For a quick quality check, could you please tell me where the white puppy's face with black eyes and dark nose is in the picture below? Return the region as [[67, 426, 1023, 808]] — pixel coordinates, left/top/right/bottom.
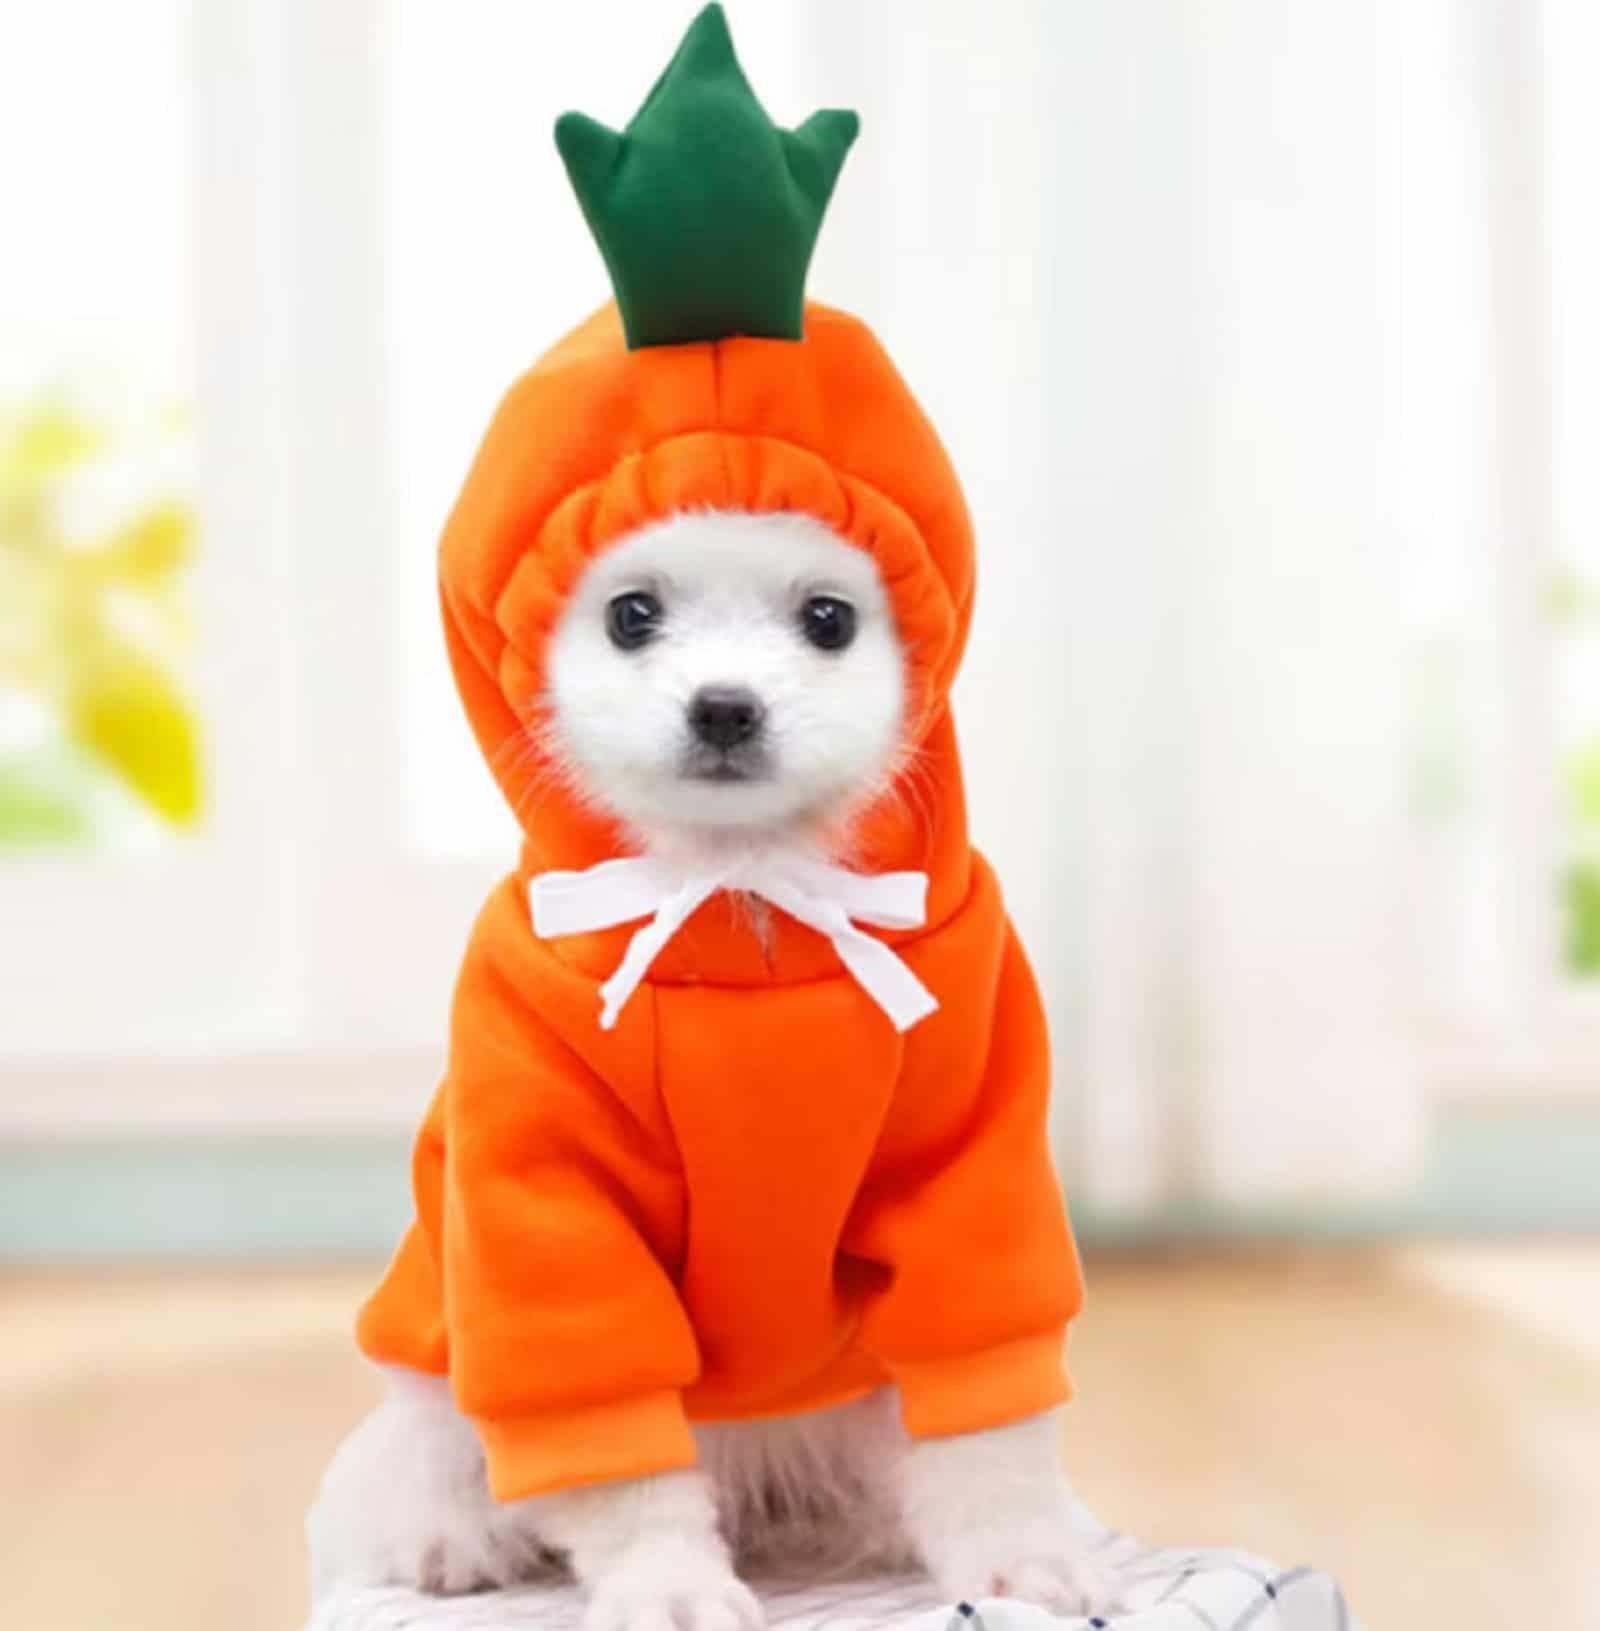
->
[[546, 511, 905, 842]]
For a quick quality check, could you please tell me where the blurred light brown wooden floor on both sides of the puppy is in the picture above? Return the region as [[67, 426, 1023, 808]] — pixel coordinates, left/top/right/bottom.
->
[[0, 1248, 1600, 1631]]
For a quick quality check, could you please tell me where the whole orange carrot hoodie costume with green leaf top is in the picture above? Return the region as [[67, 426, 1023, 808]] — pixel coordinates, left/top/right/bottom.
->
[[359, 7, 1081, 1501]]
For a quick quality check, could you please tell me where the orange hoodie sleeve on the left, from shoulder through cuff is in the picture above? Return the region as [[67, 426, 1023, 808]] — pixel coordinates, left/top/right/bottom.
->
[[442, 902, 700, 1501]]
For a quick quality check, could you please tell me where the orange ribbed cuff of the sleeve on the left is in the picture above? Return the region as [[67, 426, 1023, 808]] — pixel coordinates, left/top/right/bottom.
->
[[478, 1390, 695, 1501]]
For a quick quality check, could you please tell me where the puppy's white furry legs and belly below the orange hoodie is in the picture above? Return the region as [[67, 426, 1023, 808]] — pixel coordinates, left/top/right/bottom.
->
[[307, 1372, 1114, 1631]]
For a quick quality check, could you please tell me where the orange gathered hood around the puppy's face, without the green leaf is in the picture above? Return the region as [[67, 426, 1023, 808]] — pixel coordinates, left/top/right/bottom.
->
[[440, 305, 972, 893]]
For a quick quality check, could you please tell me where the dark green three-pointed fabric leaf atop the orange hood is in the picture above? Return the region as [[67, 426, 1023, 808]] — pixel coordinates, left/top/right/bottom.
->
[[556, 5, 860, 349]]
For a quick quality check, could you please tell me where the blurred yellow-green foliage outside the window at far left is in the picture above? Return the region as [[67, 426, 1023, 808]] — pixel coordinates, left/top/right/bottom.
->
[[0, 401, 201, 846]]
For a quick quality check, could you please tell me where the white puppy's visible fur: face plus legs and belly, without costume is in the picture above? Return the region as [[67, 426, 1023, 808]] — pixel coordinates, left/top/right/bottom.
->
[[308, 512, 1109, 1631]]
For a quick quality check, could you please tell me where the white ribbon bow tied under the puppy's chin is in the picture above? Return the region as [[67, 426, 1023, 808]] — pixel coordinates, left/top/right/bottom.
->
[[528, 855, 939, 1031]]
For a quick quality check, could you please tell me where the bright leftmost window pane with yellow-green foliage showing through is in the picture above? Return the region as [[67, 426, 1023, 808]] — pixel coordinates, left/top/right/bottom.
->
[[0, 0, 202, 855]]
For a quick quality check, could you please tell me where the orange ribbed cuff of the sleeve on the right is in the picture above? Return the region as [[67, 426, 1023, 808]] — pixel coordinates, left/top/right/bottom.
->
[[889, 1329, 1072, 1439]]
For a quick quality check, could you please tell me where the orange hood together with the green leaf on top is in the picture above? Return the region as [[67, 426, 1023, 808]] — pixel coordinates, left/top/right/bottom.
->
[[440, 7, 972, 978]]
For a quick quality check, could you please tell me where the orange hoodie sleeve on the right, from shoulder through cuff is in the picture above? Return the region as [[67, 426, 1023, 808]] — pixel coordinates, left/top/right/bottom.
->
[[848, 900, 1083, 1437]]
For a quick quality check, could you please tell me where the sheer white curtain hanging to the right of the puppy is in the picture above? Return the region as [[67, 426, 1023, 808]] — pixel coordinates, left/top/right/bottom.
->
[[801, 0, 1454, 1215]]
